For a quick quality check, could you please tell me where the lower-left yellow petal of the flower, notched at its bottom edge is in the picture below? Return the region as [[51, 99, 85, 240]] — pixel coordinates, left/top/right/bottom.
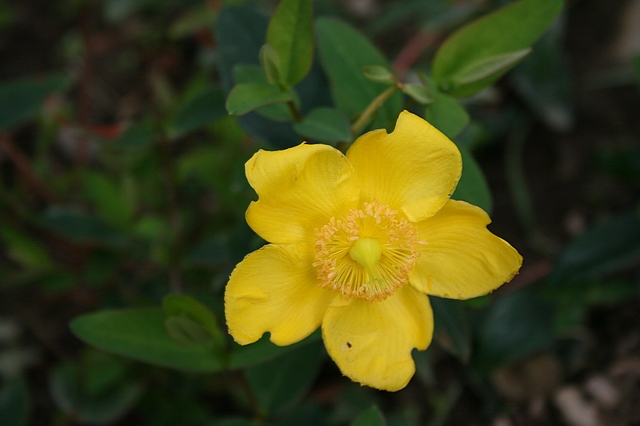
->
[[224, 245, 336, 346]]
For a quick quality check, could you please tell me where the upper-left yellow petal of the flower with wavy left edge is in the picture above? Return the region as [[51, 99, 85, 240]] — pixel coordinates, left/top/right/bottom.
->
[[245, 144, 359, 244]]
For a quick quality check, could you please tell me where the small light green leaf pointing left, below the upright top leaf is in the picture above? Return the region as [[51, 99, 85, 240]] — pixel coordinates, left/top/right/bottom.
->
[[225, 83, 294, 115]]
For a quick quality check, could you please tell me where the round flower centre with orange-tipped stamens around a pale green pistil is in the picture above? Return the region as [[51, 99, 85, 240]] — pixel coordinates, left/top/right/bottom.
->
[[313, 201, 424, 301]]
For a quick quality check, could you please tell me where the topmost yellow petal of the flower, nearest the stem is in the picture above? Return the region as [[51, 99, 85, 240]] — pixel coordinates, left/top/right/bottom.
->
[[347, 111, 462, 222]]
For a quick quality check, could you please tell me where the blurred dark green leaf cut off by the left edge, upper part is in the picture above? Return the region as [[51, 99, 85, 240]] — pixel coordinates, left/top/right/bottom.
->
[[0, 74, 68, 130]]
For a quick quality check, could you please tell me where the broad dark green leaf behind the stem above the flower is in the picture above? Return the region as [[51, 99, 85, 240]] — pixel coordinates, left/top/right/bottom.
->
[[316, 18, 403, 130]]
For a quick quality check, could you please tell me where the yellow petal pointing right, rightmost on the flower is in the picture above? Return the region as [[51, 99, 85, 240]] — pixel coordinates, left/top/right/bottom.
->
[[410, 200, 522, 299]]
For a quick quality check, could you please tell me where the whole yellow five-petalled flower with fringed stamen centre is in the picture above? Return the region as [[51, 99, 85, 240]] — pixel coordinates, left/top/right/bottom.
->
[[225, 111, 522, 391]]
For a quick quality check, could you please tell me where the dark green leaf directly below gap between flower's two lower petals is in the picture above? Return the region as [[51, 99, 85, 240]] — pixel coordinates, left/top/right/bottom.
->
[[245, 341, 325, 414]]
